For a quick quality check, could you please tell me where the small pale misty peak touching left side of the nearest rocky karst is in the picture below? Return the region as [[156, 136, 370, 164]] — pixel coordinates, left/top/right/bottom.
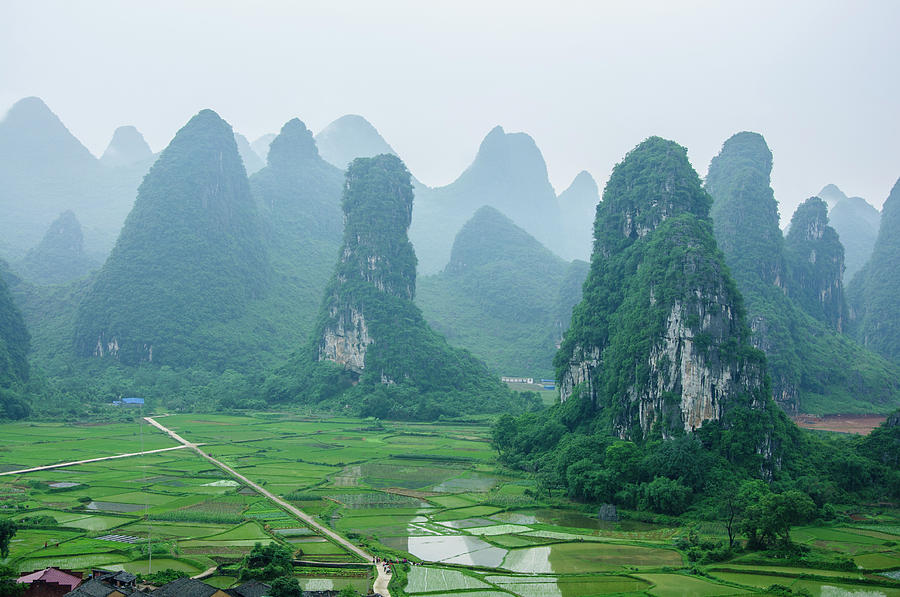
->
[[557, 170, 600, 260]]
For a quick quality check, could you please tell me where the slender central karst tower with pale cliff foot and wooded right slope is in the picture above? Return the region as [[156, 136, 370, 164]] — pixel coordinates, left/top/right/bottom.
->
[[269, 154, 536, 419]]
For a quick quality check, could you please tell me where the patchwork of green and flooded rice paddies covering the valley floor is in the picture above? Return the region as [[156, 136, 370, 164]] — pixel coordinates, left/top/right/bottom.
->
[[0, 414, 900, 597]]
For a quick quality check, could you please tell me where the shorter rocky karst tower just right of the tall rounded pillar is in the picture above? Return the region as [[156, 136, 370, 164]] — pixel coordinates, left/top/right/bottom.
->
[[785, 197, 846, 332]]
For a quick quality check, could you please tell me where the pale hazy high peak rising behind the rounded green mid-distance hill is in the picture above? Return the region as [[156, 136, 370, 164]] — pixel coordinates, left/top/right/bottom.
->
[[410, 126, 563, 274]]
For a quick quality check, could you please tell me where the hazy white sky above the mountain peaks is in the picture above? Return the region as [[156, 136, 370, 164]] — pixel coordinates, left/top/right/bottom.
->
[[0, 0, 900, 218]]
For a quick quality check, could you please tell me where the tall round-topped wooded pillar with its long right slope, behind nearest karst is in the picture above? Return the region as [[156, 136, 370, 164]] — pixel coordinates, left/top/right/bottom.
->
[[706, 132, 900, 414]]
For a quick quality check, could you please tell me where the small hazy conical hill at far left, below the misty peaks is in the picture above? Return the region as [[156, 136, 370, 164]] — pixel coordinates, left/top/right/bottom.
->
[[17, 211, 99, 284]]
